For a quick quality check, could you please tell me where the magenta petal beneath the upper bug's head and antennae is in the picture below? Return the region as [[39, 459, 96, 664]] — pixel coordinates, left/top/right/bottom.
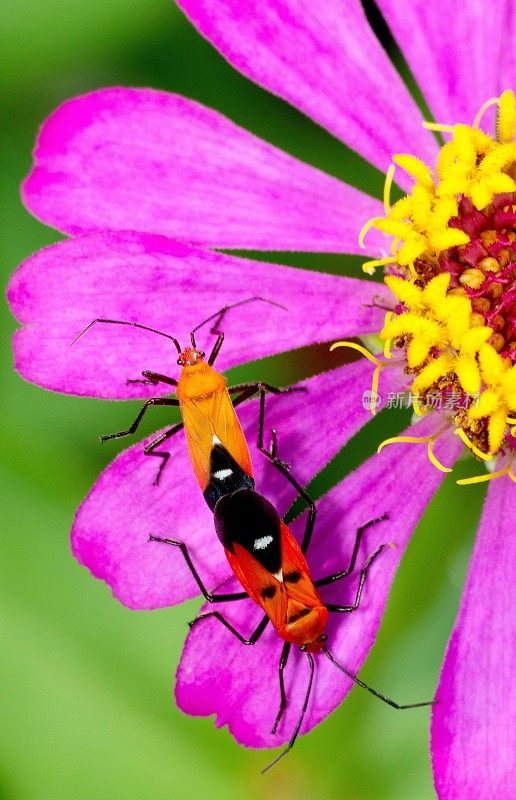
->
[[8, 232, 392, 398]]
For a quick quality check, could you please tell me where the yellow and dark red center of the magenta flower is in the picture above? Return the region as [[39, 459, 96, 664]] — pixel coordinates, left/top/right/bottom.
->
[[334, 91, 516, 484]]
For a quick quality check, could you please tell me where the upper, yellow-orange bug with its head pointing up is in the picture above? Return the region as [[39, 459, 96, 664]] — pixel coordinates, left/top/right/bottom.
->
[[72, 297, 299, 510]]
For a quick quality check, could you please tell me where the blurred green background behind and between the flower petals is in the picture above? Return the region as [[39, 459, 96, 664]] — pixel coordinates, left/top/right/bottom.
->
[[0, 0, 484, 800]]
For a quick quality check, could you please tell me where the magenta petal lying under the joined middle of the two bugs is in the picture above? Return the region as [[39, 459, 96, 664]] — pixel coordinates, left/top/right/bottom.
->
[[72, 360, 398, 608]]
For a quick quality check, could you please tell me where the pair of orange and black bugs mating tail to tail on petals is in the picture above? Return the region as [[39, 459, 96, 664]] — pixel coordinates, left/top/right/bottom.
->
[[74, 298, 434, 769]]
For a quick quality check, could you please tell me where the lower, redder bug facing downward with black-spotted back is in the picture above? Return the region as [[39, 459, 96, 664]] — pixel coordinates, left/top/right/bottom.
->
[[150, 394, 432, 772]]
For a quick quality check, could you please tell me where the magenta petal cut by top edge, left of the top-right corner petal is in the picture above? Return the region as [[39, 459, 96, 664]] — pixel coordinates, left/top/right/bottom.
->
[[178, 0, 436, 183]]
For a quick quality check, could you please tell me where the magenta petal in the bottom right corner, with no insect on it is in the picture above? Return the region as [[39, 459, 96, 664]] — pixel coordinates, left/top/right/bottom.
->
[[432, 478, 516, 800]]
